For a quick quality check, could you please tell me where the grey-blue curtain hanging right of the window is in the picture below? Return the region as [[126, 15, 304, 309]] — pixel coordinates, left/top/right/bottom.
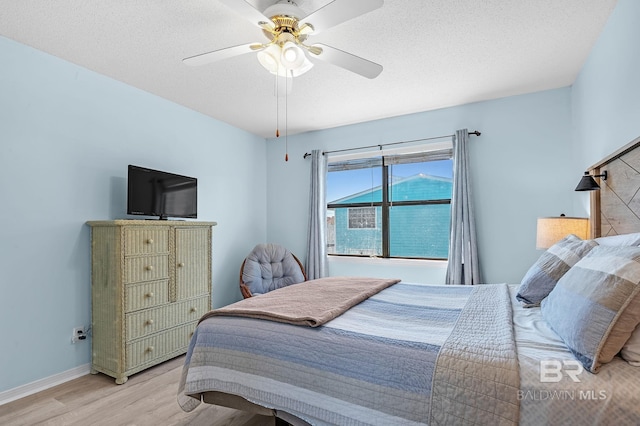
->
[[446, 129, 482, 285]]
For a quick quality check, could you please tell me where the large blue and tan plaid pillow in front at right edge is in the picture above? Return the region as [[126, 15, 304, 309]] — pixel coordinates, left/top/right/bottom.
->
[[541, 246, 640, 373]]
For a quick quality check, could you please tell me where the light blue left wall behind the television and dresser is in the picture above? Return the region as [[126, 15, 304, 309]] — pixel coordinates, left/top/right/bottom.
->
[[0, 37, 266, 392]]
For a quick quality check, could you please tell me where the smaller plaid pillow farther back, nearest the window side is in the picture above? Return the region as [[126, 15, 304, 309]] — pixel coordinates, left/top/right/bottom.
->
[[516, 234, 598, 308]]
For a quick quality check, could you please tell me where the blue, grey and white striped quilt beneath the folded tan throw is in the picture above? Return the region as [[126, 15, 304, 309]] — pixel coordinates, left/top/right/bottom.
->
[[178, 282, 519, 426]]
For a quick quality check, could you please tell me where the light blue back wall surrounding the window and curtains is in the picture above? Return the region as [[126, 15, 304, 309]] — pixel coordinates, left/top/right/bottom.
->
[[267, 88, 579, 283]]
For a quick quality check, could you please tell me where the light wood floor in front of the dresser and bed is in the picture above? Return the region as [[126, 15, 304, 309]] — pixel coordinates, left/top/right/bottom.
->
[[0, 356, 275, 426]]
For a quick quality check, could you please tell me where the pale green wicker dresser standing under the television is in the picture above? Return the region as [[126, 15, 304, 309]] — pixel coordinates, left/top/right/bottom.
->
[[87, 220, 216, 384]]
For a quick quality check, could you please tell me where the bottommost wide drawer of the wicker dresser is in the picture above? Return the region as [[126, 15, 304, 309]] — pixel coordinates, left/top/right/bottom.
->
[[125, 321, 198, 370]]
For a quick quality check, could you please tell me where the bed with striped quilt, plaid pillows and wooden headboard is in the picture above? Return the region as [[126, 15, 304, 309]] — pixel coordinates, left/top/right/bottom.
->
[[178, 141, 640, 426]]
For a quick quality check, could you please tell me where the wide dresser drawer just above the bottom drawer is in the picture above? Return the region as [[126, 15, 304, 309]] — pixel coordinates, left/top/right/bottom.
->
[[125, 296, 209, 341]]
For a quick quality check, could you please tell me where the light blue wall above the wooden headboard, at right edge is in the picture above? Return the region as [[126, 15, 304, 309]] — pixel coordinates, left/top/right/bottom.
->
[[571, 0, 640, 204]]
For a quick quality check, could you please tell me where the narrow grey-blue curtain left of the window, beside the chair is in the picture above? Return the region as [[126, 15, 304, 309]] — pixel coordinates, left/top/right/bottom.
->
[[305, 149, 328, 280]]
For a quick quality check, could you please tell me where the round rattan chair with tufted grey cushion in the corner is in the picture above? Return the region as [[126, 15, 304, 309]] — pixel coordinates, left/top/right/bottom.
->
[[240, 244, 307, 299]]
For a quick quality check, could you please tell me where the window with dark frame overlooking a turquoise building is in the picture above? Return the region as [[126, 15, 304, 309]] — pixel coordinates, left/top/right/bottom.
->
[[327, 149, 453, 259]]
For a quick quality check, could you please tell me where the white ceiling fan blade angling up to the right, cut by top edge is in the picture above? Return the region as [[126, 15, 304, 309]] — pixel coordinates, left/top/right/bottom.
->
[[298, 0, 384, 34]]
